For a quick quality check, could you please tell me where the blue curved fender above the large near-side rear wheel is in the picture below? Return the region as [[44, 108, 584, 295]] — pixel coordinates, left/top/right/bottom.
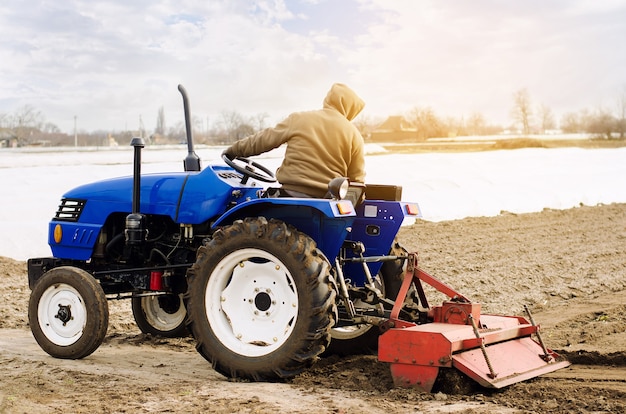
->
[[213, 198, 356, 262]]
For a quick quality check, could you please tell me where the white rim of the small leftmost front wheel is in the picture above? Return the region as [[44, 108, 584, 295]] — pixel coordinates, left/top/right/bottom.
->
[[37, 283, 87, 346]]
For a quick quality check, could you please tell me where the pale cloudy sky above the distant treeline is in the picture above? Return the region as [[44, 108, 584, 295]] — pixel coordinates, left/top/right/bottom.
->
[[0, 0, 626, 133]]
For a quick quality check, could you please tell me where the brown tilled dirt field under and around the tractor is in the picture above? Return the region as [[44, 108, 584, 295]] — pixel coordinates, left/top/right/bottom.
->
[[0, 204, 626, 413]]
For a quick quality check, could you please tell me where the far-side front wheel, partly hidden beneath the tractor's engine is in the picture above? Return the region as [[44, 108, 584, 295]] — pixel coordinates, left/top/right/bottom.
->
[[131, 294, 189, 338]]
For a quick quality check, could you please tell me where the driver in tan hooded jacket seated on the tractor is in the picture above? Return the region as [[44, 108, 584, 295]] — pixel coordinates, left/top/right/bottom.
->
[[223, 83, 365, 198]]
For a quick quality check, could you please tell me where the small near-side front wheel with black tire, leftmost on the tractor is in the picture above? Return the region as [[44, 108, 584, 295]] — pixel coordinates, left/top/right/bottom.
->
[[28, 266, 109, 359]]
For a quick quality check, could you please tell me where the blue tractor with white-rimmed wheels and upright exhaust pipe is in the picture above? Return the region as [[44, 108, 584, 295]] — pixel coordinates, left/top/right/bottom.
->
[[28, 86, 419, 380]]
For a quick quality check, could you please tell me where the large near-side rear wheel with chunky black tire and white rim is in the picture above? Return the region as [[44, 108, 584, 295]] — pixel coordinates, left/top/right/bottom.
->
[[185, 217, 336, 381]]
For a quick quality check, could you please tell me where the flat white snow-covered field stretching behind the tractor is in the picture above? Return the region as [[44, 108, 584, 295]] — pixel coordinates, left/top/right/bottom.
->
[[0, 145, 626, 260]]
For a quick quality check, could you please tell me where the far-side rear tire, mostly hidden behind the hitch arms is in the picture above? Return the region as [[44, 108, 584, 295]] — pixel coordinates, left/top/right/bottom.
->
[[326, 242, 406, 356]]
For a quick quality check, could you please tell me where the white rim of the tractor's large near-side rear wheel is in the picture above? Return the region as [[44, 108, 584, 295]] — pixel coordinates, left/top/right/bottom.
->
[[205, 249, 298, 357]]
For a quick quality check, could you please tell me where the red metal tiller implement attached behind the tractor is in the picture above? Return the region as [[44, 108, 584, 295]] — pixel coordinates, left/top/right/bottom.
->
[[378, 253, 570, 392]]
